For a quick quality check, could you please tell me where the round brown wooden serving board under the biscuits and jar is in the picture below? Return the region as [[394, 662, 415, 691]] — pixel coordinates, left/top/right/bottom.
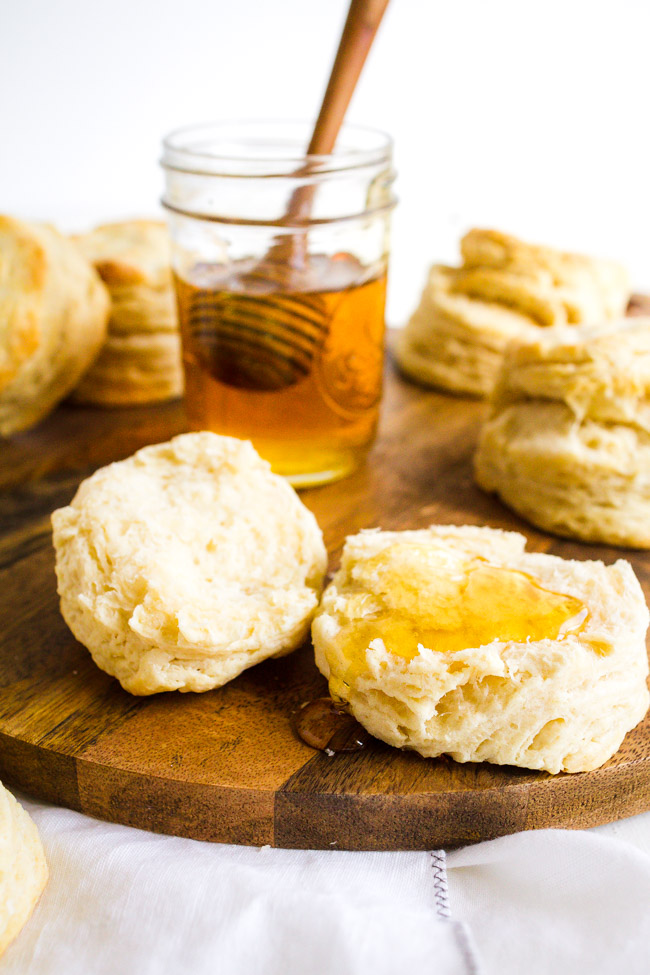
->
[[0, 324, 650, 850]]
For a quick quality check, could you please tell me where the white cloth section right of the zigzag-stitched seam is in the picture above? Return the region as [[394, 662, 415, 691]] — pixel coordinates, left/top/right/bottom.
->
[[447, 814, 650, 975]]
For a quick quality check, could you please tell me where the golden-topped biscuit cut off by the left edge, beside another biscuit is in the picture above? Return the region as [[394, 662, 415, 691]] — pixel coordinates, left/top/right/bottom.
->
[[0, 216, 109, 436]]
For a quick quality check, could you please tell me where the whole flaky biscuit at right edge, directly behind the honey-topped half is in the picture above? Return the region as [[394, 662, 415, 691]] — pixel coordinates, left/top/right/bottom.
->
[[474, 317, 650, 548]]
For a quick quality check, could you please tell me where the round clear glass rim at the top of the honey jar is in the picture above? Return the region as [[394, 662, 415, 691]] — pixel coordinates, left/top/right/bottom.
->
[[161, 119, 393, 179]]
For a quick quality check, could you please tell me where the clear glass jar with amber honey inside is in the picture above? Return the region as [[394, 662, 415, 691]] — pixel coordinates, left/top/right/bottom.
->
[[162, 122, 395, 486]]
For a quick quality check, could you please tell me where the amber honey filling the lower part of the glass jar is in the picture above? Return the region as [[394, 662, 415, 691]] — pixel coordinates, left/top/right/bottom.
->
[[176, 254, 386, 486]]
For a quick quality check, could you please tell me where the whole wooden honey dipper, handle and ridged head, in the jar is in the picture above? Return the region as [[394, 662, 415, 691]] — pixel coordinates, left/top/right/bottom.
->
[[188, 0, 388, 390]]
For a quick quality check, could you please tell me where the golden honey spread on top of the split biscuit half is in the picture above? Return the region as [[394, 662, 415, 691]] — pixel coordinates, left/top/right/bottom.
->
[[330, 543, 598, 690]]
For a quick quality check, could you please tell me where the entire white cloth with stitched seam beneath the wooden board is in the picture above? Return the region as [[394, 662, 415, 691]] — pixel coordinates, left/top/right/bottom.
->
[[0, 799, 650, 975]]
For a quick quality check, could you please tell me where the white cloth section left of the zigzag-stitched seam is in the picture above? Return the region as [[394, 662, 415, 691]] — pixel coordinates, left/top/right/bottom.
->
[[0, 800, 471, 975]]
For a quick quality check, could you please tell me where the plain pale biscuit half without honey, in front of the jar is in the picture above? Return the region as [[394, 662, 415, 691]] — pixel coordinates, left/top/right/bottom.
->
[[52, 433, 327, 694]]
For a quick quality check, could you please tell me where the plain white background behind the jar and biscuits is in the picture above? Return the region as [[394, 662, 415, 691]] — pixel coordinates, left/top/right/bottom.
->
[[0, 0, 650, 324]]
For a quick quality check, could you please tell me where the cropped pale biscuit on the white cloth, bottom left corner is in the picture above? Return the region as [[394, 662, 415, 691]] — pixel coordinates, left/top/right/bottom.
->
[[0, 785, 47, 955]]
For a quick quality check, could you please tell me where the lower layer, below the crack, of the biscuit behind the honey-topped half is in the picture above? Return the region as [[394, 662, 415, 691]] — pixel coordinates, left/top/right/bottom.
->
[[474, 402, 650, 548]]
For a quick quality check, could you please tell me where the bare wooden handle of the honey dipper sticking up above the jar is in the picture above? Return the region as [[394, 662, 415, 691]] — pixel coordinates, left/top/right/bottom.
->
[[307, 0, 388, 155]]
